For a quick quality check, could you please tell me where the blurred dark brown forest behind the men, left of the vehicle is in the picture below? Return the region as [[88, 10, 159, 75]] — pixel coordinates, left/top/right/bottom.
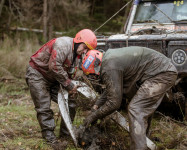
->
[[0, 0, 132, 77]]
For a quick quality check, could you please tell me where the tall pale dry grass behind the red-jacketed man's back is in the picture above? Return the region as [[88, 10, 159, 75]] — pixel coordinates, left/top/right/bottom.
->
[[0, 35, 40, 79]]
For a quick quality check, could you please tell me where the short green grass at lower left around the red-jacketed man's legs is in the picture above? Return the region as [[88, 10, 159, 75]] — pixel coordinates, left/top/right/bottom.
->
[[0, 80, 80, 150]]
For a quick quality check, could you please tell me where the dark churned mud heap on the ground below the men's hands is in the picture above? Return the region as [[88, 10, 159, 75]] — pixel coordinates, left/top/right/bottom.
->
[[79, 120, 130, 150]]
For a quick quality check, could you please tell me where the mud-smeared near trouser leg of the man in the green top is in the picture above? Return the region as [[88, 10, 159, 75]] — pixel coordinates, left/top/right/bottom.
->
[[128, 72, 177, 150]]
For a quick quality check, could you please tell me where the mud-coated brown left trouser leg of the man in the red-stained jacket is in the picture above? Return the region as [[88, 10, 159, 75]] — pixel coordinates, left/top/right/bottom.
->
[[26, 66, 76, 149]]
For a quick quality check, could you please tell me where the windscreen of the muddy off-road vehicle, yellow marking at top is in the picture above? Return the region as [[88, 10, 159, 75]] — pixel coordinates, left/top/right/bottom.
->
[[134, 0, 187, 23]]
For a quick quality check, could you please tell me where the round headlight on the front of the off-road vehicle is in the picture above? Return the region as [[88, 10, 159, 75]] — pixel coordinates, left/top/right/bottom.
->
[[172, 49, 186, 65]]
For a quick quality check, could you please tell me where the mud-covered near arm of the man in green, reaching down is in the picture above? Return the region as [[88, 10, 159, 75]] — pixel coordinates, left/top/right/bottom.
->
[[84, 70, 123, 127]]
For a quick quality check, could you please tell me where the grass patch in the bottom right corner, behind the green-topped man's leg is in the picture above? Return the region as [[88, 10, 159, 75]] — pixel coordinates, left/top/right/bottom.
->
[[151, 117, 187, 150]]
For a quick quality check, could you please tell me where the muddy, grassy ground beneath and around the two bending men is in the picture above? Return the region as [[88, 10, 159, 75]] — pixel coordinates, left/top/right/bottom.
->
[[0, 79, 187, 150]]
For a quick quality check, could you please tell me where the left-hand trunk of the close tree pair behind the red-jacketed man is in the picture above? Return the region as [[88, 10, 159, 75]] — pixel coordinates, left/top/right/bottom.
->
[[43, 0, 48, 42]]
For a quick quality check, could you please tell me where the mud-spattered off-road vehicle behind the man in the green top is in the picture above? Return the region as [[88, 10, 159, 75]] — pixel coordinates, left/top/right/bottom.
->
[[98, 0, 187, 120]]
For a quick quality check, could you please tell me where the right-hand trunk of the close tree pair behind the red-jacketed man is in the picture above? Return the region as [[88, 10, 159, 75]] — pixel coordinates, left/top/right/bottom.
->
[[48, 0, 54, 39]]
